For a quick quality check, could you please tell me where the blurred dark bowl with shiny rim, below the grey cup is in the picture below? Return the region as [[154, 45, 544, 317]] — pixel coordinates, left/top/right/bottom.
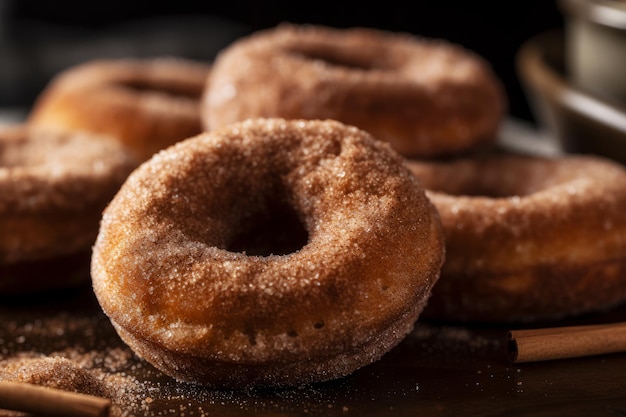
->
[[516, 30, 626, 164]]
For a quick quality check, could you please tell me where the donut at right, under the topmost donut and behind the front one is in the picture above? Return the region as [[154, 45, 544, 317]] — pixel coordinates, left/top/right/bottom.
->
[[408, 154, 626, 322]]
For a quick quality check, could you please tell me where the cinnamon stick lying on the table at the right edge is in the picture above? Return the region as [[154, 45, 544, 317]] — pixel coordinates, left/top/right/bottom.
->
[[508, 322, 626, 363]]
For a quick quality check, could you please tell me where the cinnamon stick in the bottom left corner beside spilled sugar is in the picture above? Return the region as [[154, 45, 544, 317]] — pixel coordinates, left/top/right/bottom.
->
[[0, 381, 111, 417]]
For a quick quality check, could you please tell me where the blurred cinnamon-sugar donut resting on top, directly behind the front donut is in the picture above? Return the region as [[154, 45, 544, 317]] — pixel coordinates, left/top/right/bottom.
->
[[201, 23, 507, 157]]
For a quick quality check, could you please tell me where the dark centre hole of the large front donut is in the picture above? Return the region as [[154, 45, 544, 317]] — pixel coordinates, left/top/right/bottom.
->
[[226, 200, 309, 256]]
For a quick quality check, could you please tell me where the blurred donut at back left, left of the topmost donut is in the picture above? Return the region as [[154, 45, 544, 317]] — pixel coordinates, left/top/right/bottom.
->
[[27, 57, 210, 161]]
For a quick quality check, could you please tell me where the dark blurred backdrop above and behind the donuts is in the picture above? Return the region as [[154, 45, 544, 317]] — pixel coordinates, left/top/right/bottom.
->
[[0, 0, 563, 121]]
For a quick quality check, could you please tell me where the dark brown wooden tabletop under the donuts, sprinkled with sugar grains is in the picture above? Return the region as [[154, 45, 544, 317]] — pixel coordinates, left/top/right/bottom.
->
[[0, 288, 626, 417]]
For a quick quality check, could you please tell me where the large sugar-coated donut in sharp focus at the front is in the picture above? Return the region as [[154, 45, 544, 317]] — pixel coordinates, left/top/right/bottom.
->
[[91, 118, 445, 389]]
